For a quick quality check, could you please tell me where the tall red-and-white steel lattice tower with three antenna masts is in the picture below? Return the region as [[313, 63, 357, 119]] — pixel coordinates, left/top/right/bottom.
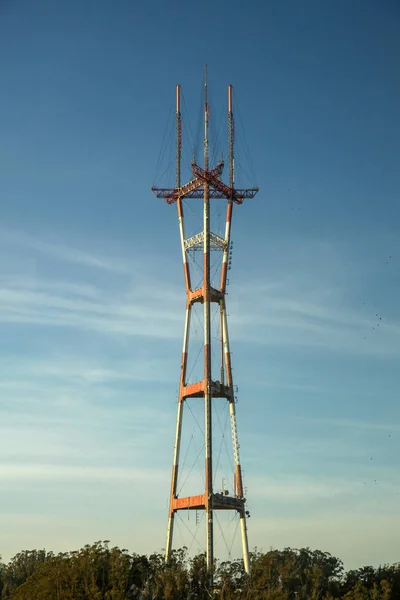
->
[[152, 67, 258, 588]]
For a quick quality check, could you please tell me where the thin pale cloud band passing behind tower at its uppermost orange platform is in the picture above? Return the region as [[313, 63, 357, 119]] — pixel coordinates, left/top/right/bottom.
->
[[0, 270, 400, 356]]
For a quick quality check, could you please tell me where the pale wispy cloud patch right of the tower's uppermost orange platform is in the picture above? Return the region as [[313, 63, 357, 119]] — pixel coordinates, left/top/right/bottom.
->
[[230, 277, 400, 357]]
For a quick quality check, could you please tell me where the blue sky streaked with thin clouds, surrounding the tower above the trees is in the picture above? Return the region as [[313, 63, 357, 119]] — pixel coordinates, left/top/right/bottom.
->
[[0, 0, 400, 567]]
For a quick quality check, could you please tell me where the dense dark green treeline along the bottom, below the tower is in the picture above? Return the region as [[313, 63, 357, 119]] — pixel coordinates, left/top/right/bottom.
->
[[0, 541, 400, 600]]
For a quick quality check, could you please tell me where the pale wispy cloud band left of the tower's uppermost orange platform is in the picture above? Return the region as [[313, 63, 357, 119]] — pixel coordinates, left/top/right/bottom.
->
[[0, 279, 184, 338]]
